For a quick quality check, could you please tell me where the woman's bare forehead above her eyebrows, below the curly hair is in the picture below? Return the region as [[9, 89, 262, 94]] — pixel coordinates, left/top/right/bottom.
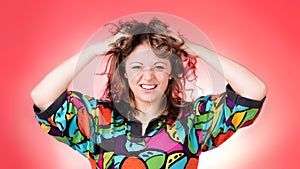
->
[[126, 43, 169, 64]]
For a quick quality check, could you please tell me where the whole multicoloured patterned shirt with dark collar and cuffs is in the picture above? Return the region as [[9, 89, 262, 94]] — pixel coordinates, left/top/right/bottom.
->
[[34, 85, 264, 169]]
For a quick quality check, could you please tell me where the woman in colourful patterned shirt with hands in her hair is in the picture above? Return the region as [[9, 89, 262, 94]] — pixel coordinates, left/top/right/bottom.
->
[[31, 18, 266, 169]]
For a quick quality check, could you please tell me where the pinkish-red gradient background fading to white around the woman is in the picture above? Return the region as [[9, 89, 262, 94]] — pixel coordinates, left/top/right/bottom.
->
[[0, 0, 300, 169]]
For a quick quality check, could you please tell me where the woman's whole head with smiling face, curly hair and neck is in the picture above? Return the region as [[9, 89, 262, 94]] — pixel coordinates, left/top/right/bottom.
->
[[105, 18, 197, 121]]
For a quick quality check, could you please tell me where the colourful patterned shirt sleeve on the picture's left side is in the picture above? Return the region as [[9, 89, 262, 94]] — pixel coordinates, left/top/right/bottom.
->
[[34, 91, 96, 157]]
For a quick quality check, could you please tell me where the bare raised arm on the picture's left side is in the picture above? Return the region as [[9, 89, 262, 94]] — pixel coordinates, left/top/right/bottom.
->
[[31, 34, 121, 111]]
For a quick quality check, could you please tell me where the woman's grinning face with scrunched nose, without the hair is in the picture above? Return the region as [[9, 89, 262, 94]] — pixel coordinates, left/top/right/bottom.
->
[[125, 44, 171, 105]]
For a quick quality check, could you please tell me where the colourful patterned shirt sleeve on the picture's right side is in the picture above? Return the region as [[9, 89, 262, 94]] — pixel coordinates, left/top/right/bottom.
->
[[194, 85, 265, 151]]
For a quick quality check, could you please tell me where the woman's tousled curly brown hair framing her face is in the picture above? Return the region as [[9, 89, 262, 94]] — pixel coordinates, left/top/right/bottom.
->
[[104, 18, 196, 123]]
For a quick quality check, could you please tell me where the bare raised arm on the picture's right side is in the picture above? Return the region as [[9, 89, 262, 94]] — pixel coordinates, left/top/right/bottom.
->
[[183, 40, 267, 100]]
